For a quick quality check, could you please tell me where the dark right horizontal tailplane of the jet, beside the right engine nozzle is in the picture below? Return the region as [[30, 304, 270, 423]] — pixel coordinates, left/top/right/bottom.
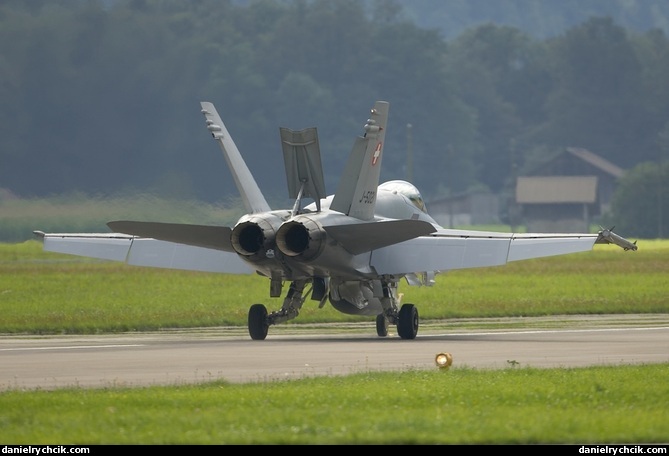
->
[[324, 220, 436, 255]]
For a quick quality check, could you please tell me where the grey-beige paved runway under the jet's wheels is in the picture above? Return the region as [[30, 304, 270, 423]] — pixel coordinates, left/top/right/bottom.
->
[[0, 314, 669, 390]]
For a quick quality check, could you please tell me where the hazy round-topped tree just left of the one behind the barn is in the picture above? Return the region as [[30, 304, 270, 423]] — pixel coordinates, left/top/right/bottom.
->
[[447, 24, 550, 192]]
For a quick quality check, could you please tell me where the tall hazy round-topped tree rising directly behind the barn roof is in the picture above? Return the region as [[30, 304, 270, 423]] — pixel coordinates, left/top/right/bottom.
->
[[534, 18, 647, 168]]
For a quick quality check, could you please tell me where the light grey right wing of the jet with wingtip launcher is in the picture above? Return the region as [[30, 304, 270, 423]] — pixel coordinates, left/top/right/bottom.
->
[[370, 229, 636, 274]]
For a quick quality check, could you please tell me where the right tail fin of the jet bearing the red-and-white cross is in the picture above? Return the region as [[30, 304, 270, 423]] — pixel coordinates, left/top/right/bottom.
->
[[330, 101, 389, 220]]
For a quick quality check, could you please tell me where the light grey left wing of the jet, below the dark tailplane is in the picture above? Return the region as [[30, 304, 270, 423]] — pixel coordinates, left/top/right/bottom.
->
[[35, 231, 254, 274]]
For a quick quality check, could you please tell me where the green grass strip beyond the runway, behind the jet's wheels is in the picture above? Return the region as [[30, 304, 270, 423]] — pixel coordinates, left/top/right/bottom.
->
[[0, 241, 669, 334]]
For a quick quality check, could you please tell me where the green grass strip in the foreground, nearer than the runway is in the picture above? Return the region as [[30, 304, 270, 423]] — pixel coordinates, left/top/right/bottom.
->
[[0, 364, 669, 444]]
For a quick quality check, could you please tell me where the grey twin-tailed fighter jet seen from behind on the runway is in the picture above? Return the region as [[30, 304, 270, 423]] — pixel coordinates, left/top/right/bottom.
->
[[35, 101, 637, 340]]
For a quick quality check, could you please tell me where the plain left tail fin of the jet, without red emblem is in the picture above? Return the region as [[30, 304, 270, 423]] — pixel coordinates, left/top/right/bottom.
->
[[200, 101, 271, 214]]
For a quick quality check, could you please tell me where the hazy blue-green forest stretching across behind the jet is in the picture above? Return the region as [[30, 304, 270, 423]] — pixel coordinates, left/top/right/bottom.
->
[[0, 0, 669, 235]]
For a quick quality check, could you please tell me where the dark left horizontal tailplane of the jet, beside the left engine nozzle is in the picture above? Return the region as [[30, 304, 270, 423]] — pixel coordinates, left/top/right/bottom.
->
[[107, 220, 234, 252]]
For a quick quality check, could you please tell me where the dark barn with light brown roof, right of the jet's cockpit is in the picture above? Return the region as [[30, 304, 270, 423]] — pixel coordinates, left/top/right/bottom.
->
[[515, 147, 625, 233]]
